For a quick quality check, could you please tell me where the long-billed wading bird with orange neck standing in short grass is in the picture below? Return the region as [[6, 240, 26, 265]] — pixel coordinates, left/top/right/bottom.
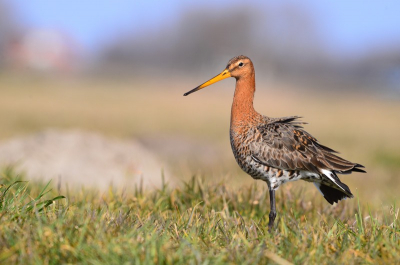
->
[[184, 55, 366, 231]]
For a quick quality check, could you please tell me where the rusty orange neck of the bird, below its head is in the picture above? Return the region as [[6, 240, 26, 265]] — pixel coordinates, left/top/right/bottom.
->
[[231, 74, 257, 129]]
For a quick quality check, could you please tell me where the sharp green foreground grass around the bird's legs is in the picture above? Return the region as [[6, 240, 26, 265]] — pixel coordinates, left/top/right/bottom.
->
[[0, 169, 400, 264]]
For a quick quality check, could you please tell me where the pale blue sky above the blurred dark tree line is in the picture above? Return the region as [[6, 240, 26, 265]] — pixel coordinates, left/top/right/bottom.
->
[[6, 0, 400, 53]]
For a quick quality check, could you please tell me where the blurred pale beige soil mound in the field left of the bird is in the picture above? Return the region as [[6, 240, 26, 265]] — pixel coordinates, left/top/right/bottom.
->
[[0, 130, 171, 190]]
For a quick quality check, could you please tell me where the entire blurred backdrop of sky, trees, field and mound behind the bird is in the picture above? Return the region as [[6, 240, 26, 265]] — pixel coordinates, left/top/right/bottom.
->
[[0, 0, 400, 204]]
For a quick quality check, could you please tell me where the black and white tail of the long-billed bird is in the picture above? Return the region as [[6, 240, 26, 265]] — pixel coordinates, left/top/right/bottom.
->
[[314, 169, 354, 204]]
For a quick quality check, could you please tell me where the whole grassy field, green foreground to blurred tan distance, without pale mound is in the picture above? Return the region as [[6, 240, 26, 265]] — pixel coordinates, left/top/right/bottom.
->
[[0, 75, 400, 264]]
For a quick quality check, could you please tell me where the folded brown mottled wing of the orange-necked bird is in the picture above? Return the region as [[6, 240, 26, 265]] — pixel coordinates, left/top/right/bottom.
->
[[250, 116, 364, 174]]
